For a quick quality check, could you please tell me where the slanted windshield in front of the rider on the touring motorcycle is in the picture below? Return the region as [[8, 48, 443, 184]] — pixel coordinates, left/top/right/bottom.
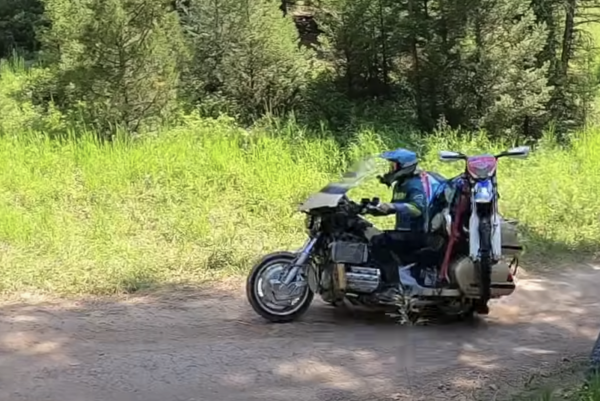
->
[[298, 156, 381, 212]]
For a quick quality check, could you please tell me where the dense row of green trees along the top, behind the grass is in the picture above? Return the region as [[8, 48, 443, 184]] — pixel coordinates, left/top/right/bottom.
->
[[0, 0, 598, 139]]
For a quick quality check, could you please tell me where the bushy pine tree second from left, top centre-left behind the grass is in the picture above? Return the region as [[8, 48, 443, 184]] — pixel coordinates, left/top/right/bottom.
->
[[179, 0, 310, 118]]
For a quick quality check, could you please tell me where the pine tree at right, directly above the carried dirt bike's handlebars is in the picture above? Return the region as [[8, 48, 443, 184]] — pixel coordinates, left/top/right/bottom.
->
[[454, 0, 550, 134]]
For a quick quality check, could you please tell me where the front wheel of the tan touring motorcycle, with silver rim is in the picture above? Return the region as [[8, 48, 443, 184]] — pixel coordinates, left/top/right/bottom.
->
[[246, 252, 314, 323]]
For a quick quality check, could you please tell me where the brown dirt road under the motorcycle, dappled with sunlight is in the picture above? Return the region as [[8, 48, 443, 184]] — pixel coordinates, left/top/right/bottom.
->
[[0, 267, 600, 401]]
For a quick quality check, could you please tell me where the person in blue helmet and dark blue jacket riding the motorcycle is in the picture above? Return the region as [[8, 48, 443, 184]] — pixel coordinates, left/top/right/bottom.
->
[[368, 148, 428, 303]]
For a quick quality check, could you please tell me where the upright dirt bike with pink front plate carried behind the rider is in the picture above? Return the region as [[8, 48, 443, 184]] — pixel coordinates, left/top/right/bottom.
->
[[432, 146, 529, 314]]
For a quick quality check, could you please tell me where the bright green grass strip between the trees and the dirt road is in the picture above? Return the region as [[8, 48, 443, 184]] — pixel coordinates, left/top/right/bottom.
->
[[0, 56, 600, 295]]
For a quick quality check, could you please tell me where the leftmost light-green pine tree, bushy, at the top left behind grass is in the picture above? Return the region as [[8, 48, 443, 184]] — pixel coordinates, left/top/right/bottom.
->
[[43, 0, 184, 132]]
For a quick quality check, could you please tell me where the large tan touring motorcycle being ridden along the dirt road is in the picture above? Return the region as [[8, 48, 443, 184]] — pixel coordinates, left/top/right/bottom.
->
[[246, 152, 519, 323]]
